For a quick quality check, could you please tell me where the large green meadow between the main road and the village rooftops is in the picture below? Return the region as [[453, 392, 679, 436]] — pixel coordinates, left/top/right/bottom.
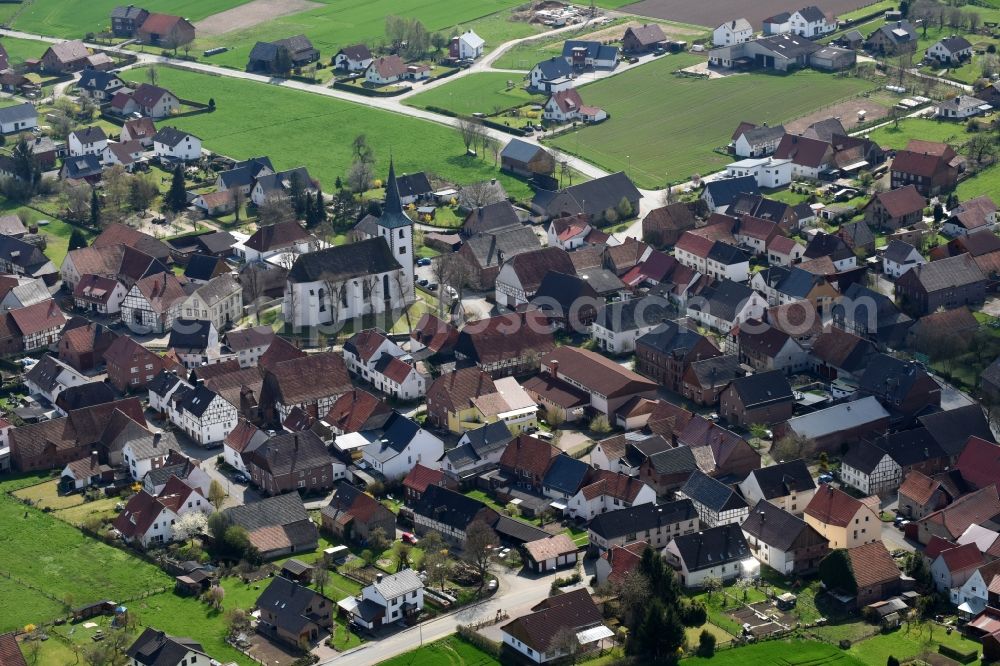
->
[[123, 67, 530, 199]]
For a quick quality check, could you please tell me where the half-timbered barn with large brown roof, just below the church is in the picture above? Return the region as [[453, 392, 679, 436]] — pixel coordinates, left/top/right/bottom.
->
[[260, 352, 353, 422]]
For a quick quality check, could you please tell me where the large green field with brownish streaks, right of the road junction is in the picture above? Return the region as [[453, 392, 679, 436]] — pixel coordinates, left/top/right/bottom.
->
[[553, 54, 873, 188]]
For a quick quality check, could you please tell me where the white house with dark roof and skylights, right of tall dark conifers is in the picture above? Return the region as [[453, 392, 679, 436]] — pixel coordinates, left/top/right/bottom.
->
[[663, 523, 759, 588]]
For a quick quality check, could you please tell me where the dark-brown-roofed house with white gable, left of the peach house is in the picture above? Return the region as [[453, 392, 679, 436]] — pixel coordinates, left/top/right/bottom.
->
[[740, 500, 830, 576]]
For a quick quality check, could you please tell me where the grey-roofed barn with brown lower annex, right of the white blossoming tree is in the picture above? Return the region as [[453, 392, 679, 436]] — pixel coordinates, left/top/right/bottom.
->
[[222, 493, 319, 561]]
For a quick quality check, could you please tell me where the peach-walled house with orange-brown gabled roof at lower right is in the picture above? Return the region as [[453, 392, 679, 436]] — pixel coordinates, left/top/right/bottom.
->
[[804, 483, 882, 550]]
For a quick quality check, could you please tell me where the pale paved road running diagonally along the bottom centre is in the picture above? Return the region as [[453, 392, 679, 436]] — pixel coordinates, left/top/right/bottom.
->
[[320, 573, 568, 666]]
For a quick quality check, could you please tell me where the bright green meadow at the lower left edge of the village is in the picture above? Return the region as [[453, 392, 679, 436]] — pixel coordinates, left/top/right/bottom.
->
[[0, 484, 171, 630]]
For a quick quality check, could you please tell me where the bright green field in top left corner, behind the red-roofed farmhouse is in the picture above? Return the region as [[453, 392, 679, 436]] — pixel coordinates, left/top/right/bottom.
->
[[12, 0, 250, 39]]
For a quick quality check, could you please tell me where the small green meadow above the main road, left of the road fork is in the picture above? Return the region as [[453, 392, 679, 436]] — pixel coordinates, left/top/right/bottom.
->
[[406, 72, 545, 115]]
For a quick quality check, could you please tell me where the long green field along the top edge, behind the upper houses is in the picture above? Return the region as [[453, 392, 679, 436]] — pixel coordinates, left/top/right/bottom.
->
[[192, 0, 532, 69]]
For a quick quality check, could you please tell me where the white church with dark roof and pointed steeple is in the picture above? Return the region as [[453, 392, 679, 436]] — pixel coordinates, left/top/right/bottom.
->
[[283, 160, 415, 329]]
